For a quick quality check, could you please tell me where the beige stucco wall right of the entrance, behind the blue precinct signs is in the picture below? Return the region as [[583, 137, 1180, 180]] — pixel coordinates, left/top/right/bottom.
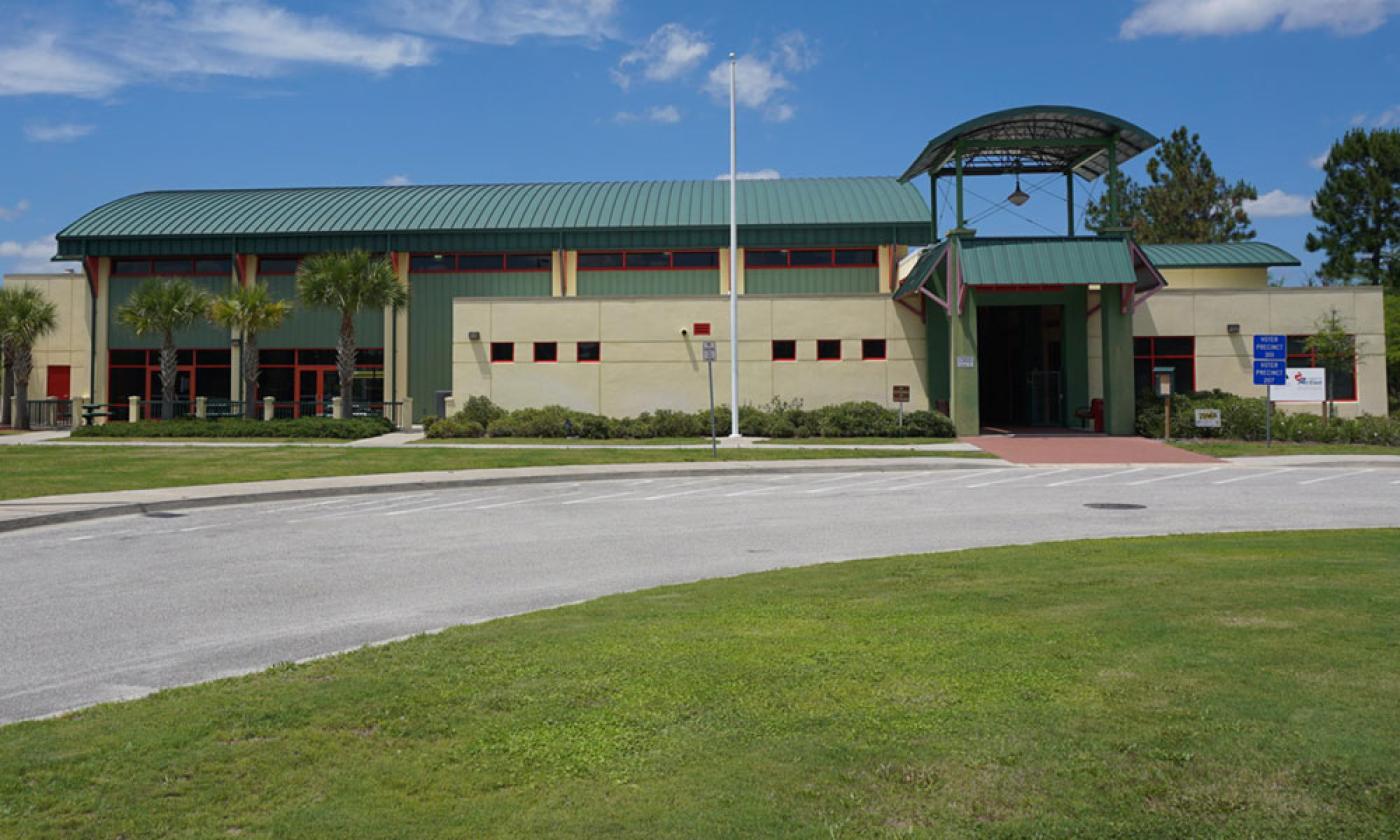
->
[[1089, 287, 1387, 417]]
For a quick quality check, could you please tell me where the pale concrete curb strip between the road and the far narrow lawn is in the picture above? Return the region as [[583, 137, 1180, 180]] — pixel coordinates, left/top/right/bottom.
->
[[0, 458, 1014, 533]]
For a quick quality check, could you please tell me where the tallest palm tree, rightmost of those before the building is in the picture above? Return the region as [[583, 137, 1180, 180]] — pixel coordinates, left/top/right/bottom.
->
[[297, 249, 409, 413]]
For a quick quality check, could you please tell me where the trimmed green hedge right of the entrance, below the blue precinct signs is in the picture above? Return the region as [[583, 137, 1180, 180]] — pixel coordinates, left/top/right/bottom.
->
[[1137, 391, 1400, 447]]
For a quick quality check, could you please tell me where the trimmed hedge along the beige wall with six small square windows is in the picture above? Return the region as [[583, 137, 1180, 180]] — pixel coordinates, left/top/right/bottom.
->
[[423, 396, 956, 440]]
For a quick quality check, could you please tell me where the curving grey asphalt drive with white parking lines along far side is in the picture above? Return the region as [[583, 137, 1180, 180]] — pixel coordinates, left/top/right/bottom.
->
[[0, 463, 1400, 721]]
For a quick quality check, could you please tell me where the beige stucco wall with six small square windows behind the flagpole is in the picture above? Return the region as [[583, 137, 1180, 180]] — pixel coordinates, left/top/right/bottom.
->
[[452, 295, 928, 417]]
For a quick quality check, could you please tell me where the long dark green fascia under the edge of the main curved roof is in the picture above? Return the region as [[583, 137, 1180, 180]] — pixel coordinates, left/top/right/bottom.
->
[[59, 225, 931, 260]]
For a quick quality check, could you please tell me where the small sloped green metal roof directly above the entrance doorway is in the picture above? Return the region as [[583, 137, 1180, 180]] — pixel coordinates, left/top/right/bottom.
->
[[959, 237, 1138, 286]]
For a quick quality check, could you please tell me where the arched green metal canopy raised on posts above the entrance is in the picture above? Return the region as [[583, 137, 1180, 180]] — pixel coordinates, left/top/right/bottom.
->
[[900, 105, 1158, 181]]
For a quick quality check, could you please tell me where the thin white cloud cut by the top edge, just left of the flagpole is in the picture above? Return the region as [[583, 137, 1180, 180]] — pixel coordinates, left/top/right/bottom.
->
[[384, 0, 617, 43]]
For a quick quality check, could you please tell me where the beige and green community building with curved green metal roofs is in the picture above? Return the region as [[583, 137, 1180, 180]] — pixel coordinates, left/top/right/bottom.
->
[[6, 106, 1386, 434]]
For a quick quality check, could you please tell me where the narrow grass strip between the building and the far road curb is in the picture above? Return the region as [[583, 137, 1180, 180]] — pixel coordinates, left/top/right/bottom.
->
[[0, 441, 980, 500]]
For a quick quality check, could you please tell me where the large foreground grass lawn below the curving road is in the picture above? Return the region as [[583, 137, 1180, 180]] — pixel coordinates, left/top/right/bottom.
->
[[0, 531, 1400, 839]]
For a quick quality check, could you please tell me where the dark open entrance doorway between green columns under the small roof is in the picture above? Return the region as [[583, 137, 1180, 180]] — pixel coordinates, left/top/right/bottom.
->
[[977, 305, 1065, 428]]
